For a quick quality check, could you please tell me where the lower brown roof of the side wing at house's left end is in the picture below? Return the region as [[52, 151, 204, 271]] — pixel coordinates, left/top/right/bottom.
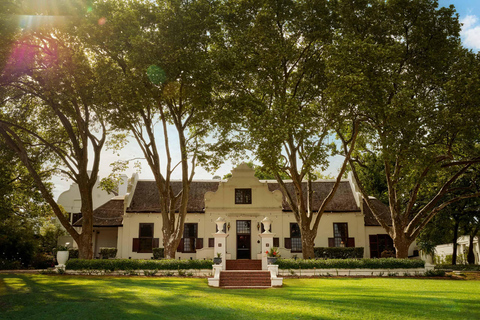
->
[[74, 198, 124, 227]]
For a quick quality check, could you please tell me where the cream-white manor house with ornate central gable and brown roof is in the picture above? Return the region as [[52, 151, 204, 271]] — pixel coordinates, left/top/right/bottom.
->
[[58, 164, 418, 260]]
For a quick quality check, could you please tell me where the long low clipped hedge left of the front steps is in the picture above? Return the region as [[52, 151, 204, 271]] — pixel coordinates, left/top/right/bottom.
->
[[65, 259, 213, 271]]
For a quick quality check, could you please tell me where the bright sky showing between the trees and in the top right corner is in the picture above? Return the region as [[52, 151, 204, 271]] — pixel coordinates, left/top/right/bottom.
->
[[53, 0, 480, 197]]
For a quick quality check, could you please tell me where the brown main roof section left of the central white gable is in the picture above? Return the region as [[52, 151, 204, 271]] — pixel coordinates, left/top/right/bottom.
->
[[127, 180, 219, 213]]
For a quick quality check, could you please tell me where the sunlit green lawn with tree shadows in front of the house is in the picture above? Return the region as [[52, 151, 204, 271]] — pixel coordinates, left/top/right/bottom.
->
[[0, 274, 480, 320]]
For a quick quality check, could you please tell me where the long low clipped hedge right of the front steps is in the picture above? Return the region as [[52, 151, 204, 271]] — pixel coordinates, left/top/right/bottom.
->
[[276, 258, 425, 269]]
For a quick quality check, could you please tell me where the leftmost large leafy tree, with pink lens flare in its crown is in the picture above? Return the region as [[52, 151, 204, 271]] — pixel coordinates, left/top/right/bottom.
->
[[0, 1, 108, 259]]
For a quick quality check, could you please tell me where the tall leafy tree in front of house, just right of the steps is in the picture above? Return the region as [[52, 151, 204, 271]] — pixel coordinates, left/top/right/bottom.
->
[[220, 1, 359, 258]]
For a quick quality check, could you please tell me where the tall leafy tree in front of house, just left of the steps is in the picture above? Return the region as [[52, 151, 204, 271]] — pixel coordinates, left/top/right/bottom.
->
[[79, 0, 228, 258]]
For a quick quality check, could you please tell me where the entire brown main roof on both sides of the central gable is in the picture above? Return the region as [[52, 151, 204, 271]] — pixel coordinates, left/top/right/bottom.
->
[[127, 180, 360, 213]]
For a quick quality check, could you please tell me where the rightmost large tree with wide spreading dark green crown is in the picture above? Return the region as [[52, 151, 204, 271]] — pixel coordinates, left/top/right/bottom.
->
[[330, 0, 480, 258]]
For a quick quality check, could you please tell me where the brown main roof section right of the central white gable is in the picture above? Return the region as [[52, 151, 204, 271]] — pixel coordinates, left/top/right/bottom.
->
[[268, 181, 360, 212]]
